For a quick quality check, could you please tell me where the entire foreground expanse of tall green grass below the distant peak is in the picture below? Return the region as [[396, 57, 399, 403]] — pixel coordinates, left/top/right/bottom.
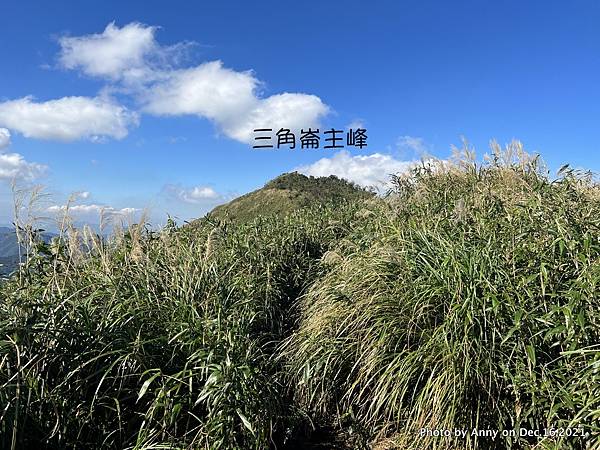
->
[[0, 144, 600, 450]]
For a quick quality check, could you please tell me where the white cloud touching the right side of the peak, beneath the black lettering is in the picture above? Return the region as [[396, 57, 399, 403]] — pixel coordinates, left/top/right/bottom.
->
[[296, 150, 416, 190]]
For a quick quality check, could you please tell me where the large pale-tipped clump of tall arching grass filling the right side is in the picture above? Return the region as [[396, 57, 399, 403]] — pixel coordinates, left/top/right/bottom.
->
[[283, 143, 600, 449]]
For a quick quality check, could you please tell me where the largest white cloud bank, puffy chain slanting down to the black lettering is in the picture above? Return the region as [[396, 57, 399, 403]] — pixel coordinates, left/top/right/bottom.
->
[[59, 23, 329, 143]]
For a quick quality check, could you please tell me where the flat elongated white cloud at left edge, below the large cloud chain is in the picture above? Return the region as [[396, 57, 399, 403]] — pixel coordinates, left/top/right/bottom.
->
[[0, 97, 139, 141]]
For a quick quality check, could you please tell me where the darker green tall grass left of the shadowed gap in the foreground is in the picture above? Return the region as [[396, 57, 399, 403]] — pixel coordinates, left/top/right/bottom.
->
[[0, 205, 360, 449]]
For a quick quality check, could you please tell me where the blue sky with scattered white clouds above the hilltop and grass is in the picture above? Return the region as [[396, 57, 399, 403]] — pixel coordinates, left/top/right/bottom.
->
[[0, 0, 600, 229]]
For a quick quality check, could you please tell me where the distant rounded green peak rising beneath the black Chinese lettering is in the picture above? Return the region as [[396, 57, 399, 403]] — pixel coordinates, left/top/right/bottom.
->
[[211, 172, 373, 222]]
